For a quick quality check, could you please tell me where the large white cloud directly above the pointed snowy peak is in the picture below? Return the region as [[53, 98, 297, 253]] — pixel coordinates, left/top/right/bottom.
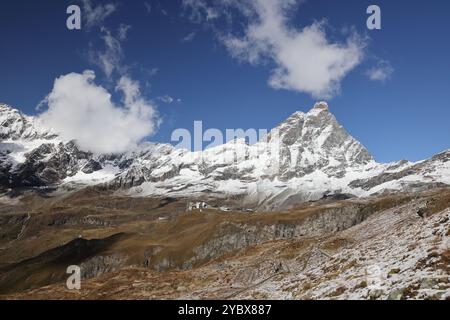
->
[[184, 0, 365, 98]]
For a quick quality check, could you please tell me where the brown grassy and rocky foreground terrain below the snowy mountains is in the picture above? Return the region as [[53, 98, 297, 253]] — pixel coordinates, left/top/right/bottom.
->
[[0, 188, 450, 299]]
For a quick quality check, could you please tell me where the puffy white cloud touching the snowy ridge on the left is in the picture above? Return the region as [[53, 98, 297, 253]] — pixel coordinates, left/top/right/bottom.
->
[[39, 71, 159, 153]]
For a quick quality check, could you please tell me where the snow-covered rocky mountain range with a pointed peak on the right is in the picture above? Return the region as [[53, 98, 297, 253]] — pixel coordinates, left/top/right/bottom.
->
[[0, 102, 450, 209]]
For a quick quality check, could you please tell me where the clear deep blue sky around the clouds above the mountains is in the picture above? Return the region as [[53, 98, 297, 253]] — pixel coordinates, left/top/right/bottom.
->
[[0, 0, 450, 162]]
